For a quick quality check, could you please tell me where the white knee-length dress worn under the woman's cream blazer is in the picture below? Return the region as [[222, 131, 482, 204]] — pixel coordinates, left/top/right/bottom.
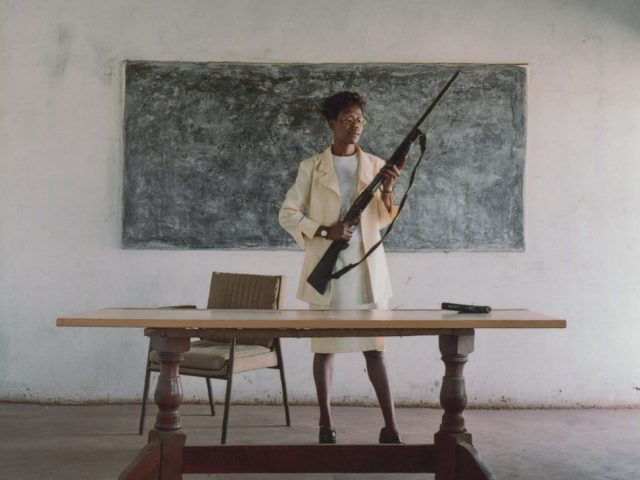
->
[[309, 155, 387, 353]]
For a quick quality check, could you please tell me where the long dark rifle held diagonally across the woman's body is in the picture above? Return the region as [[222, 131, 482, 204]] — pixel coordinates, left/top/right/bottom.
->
[[307, 70, 460, 295]]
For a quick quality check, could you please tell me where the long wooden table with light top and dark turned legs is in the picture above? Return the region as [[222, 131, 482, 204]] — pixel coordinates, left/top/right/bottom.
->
[[57, 309, 566, 480]]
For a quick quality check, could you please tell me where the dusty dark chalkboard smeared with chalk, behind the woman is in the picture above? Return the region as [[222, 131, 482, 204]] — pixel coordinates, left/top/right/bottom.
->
[[123, 61, 526, 251]]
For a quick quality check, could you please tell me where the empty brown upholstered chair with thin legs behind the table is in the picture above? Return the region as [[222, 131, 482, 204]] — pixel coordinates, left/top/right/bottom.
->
[[138, 272, 291, 444]]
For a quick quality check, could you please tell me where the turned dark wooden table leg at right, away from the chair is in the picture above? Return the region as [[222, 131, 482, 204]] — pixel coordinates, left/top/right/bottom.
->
[[435, 331, 495, 480]]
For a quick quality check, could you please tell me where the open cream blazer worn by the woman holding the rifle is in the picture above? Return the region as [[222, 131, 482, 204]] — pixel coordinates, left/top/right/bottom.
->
[[279, 144, 395, 305]]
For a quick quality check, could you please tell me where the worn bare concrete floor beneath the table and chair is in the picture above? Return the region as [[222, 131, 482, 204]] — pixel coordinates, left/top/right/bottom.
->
[[0, 403, 640, 480]]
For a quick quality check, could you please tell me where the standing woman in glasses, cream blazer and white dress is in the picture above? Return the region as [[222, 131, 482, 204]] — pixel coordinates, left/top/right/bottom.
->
[[279, 92, 402, 443]]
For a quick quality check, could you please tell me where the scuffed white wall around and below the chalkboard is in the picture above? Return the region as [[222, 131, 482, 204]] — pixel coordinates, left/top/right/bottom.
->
[[0, 0, 640, 406]]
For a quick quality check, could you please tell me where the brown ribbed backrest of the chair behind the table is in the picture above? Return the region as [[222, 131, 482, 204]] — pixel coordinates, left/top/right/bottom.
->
[[207, 272, 284, 347]]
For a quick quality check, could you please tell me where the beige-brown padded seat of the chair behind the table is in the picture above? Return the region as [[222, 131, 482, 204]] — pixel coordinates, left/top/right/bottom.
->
[[149, 340, 278, 377]]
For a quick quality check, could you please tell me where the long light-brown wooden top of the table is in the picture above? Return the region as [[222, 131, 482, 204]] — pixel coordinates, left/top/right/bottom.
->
[[56, 308, 566, 333]]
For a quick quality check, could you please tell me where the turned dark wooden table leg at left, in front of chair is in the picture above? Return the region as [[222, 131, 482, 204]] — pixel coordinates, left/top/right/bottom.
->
[[119, 333, 190, 480]]
